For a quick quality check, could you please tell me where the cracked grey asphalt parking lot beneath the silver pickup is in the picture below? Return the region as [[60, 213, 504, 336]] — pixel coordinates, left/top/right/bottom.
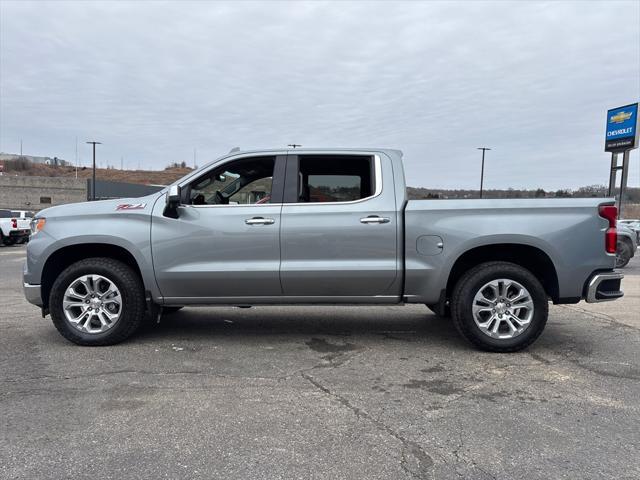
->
[[0, 246, 640, 480]]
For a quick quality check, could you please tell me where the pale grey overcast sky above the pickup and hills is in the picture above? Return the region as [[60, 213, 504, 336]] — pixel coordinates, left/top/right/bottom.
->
[[0, 0, 640, 189]]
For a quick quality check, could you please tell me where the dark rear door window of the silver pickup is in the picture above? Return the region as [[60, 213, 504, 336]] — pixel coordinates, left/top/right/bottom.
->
[[298, 155, 374, 203]]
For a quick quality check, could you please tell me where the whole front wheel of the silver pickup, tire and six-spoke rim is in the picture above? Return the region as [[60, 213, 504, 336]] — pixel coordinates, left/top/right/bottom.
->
[[49, 258, 145, 345]]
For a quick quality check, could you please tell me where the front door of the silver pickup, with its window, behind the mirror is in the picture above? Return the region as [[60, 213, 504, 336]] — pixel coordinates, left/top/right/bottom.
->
[[151, 156, 286, 304]]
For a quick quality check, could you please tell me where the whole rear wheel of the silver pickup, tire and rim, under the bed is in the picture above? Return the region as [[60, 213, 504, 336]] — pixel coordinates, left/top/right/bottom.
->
[[451, 262, 549, 352]]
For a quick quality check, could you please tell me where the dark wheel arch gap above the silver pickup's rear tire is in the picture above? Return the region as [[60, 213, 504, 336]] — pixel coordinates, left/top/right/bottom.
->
[[446, 243, 560, 302]]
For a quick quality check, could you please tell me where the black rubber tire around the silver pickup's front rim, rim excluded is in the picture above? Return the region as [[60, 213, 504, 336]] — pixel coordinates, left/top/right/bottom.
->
[[49, 257, 145, 346]]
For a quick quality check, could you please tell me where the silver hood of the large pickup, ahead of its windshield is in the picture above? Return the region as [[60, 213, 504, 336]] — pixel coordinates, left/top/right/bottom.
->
[[36, 190, 164, 218]]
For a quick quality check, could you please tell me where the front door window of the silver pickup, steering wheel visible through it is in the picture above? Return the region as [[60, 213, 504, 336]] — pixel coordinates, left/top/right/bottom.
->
[[188, 157, 275, 205]]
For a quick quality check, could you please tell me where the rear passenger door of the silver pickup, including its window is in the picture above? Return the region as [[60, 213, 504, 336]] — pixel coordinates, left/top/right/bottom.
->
[[280, 154, 401, 302]]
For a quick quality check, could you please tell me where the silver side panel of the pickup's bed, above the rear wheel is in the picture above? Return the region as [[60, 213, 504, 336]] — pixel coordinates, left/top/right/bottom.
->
[[404, 198, 615, 303]]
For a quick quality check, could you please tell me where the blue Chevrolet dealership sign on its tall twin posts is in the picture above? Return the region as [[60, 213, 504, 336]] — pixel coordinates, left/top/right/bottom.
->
[[604, 103, 640, 218]]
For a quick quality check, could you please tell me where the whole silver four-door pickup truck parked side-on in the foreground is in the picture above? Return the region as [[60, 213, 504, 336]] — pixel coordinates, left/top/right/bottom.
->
[[24, 149, 623, 352]]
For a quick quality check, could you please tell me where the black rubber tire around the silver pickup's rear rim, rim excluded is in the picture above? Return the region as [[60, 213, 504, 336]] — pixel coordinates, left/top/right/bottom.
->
[[451, 262, 549, 353]]
